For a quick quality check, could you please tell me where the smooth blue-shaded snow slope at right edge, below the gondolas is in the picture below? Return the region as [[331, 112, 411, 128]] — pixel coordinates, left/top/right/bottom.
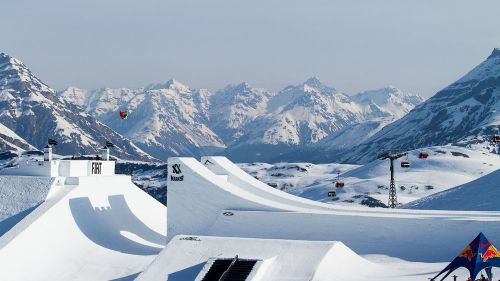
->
[[403, 169, 500, 211]]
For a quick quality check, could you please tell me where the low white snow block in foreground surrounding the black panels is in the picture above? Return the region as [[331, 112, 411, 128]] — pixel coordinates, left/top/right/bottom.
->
[[137, 235, 381, 281]]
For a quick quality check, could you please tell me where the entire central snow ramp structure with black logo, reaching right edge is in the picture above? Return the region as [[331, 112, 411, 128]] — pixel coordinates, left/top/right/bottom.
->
[[168, 157, 500, 262]]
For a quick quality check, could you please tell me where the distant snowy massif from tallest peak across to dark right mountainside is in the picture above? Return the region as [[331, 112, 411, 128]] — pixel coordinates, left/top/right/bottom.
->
[[227, 77, 423, 162]]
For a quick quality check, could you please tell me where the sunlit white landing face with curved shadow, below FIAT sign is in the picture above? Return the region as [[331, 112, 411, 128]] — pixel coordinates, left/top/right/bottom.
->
[[0, 175, 166, 281]]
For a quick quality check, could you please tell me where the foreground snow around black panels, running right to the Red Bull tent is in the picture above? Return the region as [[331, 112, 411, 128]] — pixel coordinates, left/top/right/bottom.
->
[[136, 235, 460, 281]]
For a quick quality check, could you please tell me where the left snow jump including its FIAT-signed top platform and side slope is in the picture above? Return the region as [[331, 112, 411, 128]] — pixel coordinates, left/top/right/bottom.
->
[[0, 160, 166, 280]]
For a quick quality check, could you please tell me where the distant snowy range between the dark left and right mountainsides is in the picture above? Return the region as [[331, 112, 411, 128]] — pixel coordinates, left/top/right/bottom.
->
[[58, 77, 423, 161]]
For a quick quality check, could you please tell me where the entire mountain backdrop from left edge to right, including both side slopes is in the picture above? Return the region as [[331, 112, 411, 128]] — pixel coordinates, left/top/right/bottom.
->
[[0, 49, 500, 163]]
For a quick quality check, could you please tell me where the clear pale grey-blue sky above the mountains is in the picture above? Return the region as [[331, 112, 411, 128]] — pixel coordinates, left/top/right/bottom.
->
[[0, 0, 500, 96]]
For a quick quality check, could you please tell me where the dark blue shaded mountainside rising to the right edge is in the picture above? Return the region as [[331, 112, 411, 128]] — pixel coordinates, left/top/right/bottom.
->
[[342, 49, 500, 162]]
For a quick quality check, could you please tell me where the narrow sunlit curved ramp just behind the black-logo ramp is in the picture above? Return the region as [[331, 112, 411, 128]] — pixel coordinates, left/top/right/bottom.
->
[[201, 156, 338, 210]]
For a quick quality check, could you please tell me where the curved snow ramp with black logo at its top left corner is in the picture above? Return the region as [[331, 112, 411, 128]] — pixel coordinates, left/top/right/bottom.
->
[[167, 157, 316, 240]]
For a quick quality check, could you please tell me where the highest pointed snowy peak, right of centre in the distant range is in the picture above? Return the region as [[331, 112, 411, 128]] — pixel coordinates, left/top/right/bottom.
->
[[227, 78, 364, 161]]
